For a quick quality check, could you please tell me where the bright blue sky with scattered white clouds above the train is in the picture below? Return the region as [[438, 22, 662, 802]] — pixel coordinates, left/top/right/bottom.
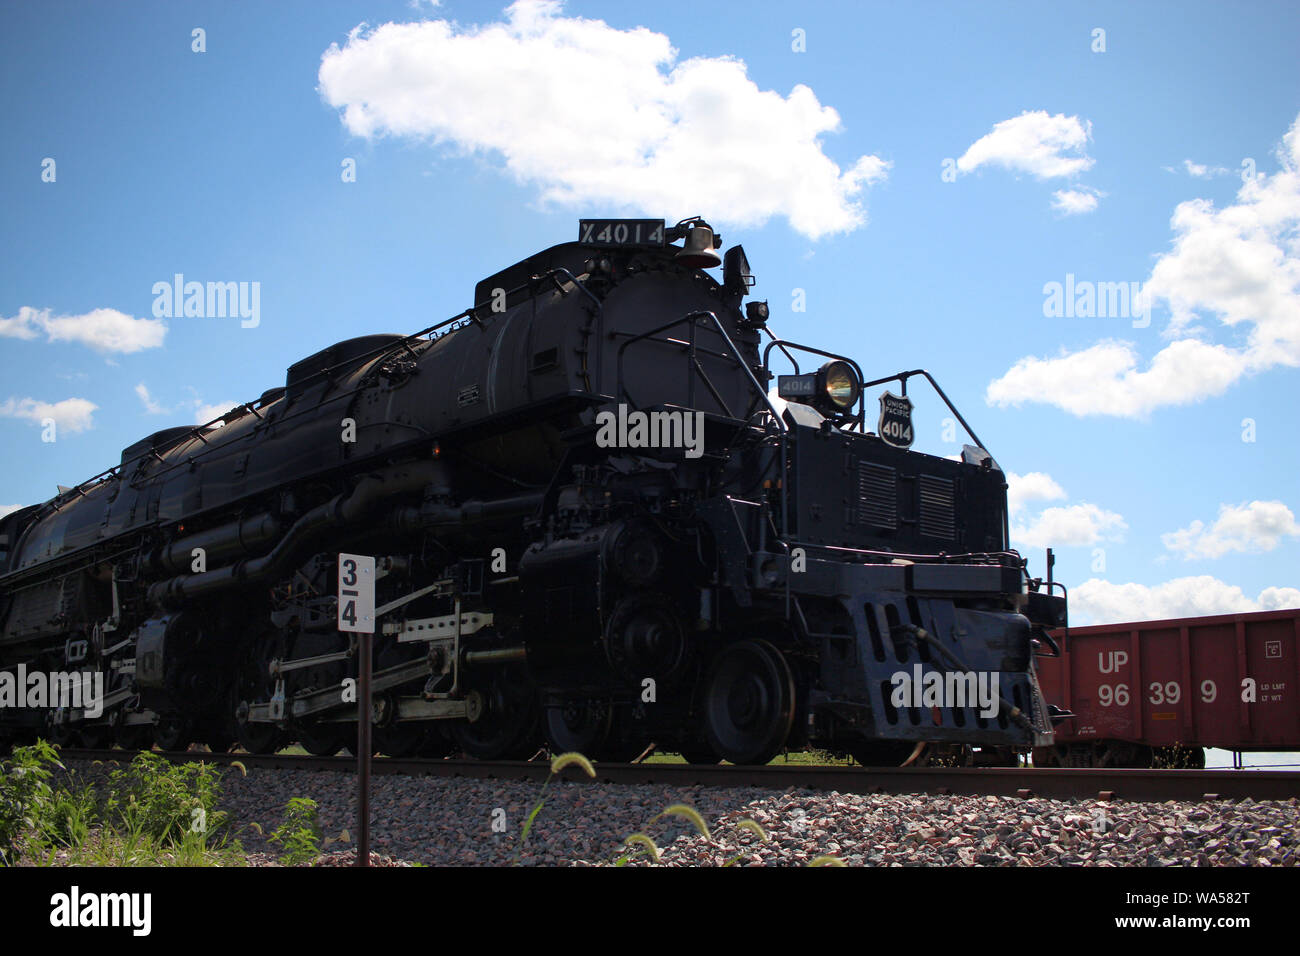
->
[[0, 0, 1300, 632]]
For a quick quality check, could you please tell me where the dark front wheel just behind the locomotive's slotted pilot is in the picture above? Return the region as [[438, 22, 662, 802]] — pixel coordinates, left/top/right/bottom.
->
[[705, 641, 794, 763]]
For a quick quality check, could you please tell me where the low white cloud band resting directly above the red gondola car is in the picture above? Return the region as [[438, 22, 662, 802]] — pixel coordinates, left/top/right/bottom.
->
[[1070, 575, 1300, 626]]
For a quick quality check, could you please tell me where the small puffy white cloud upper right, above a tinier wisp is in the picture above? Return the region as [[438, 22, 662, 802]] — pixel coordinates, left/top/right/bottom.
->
[[957, 109, 1095, 179]]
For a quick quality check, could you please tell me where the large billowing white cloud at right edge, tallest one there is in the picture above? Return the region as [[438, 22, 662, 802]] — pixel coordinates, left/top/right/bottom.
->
[[984, 110, 1300, 418]]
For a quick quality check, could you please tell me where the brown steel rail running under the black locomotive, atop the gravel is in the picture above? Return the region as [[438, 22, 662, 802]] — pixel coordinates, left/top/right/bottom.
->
[[61, 749, 1300, 801]]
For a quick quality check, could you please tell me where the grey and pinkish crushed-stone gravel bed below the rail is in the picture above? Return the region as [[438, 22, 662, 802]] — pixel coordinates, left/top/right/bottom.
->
[[58, 761, 1300, 866]]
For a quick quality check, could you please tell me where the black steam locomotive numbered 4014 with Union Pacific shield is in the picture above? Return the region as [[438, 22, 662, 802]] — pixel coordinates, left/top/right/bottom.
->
[[0, 220, 1065, 763]]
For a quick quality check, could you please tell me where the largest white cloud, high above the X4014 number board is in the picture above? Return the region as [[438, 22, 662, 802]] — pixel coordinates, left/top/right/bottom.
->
[[319, 0, 891, 238]]
